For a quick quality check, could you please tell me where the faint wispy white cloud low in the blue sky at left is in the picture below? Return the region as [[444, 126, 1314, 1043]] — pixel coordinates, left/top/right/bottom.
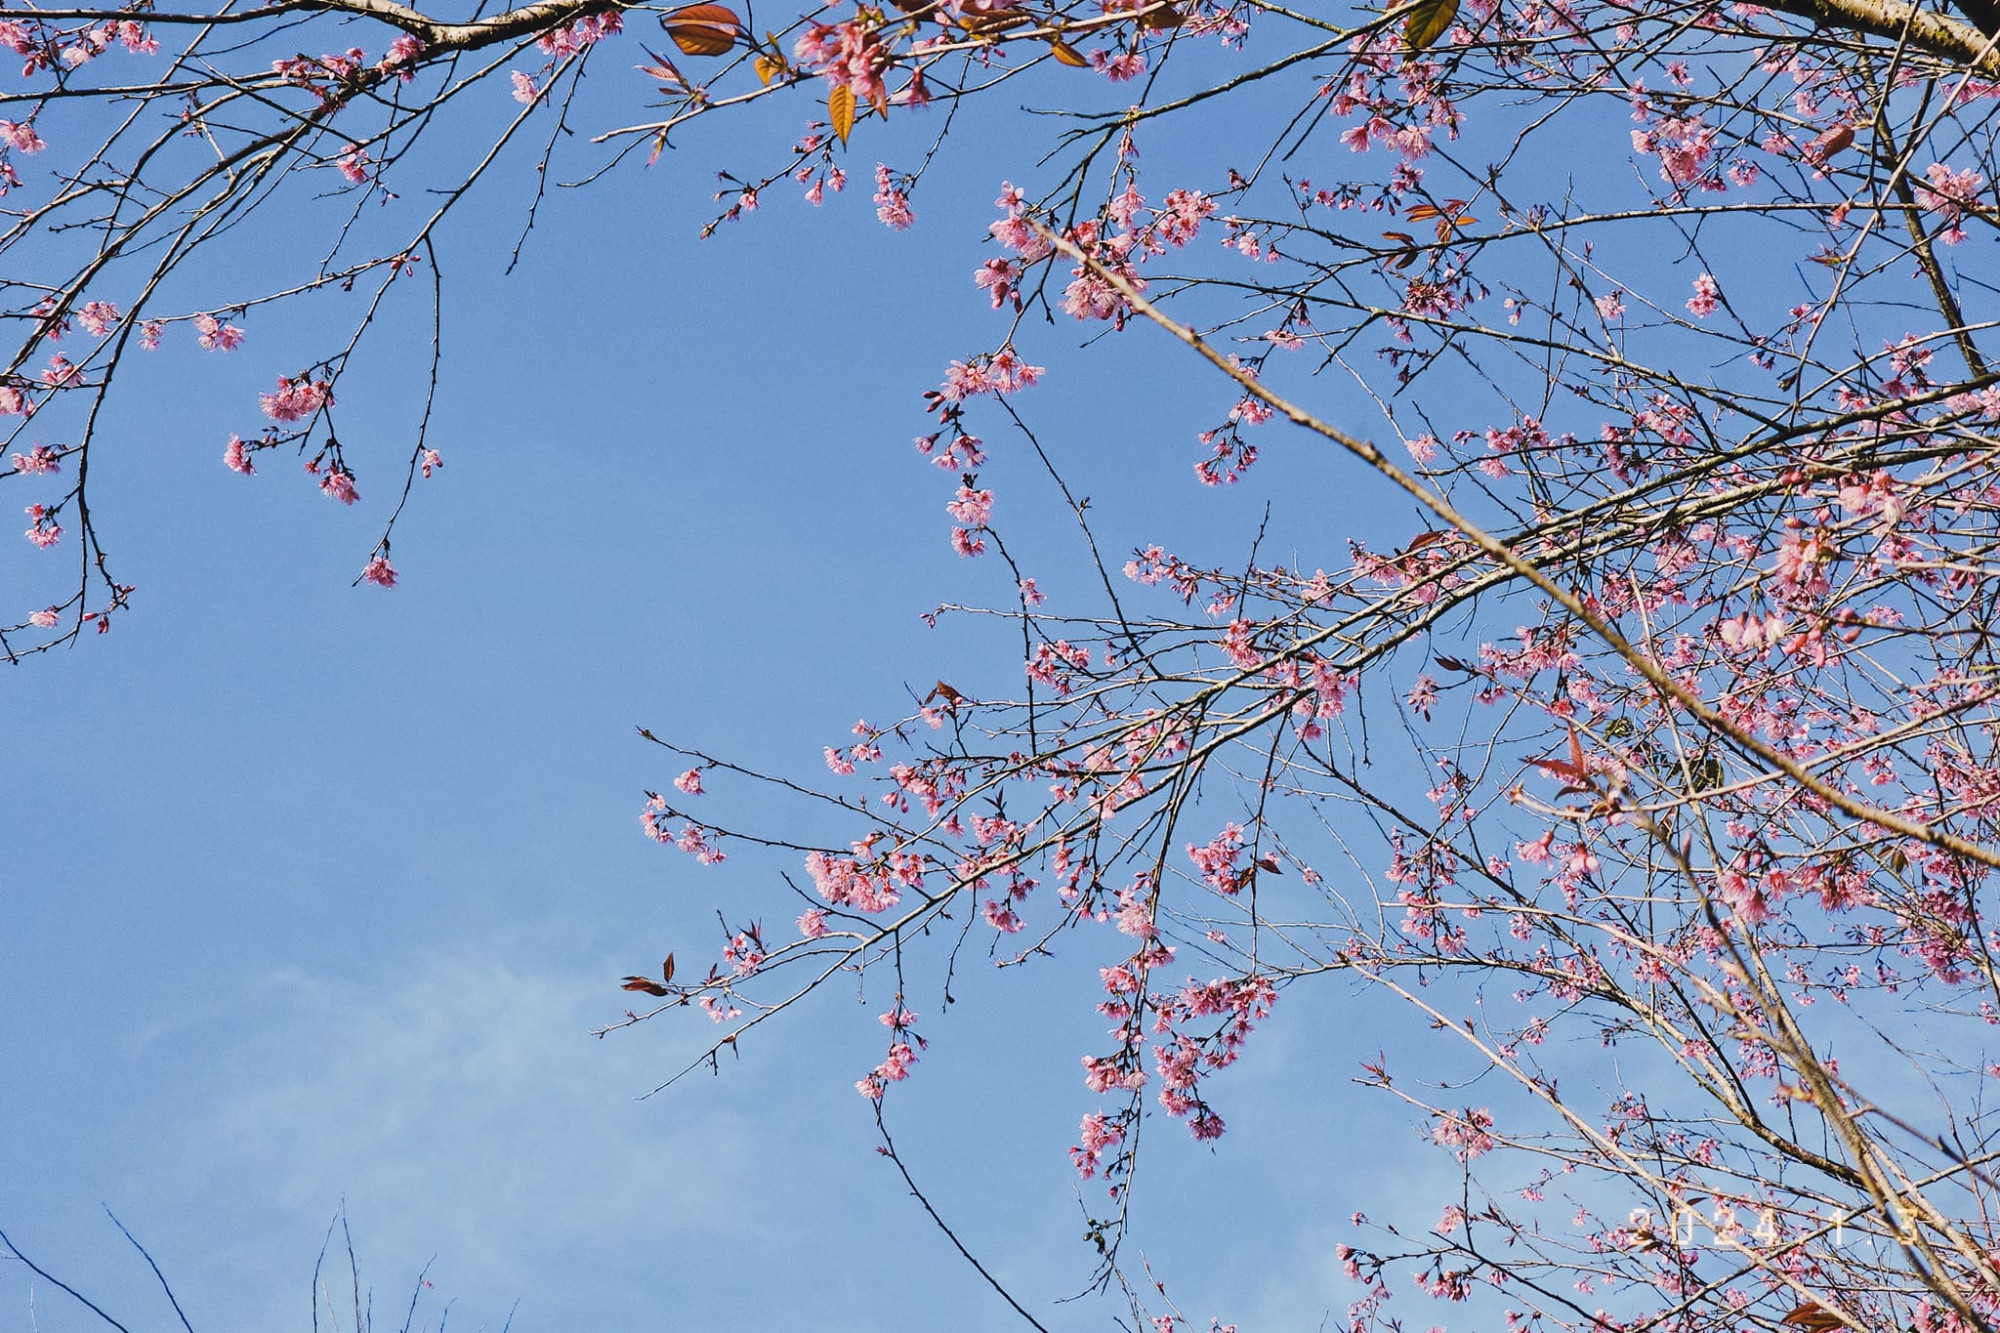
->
[[186, 949, 756, 1327]]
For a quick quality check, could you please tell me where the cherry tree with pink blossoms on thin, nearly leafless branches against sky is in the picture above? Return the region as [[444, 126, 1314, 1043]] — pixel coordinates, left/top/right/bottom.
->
[[11, 0, 2000, 1333]]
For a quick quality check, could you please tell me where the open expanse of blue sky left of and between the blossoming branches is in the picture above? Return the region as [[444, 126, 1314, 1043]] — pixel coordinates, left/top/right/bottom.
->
[[0, 48, 1448, 1333]]
